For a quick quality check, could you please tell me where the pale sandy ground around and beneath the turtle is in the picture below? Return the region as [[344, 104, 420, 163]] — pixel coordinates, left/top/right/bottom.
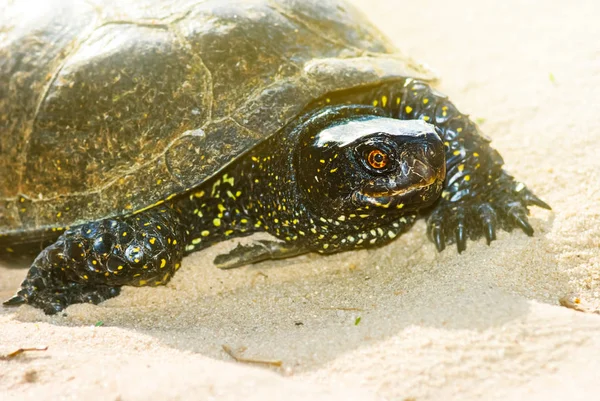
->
[[0, 0, 600, 401]]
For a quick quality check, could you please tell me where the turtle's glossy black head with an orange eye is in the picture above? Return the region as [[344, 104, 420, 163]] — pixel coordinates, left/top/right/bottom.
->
[[295, 106, 446, 219]]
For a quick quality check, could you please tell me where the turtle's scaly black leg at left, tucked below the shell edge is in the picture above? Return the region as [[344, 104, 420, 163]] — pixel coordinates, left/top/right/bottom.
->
[[4, 206, 186, 315]]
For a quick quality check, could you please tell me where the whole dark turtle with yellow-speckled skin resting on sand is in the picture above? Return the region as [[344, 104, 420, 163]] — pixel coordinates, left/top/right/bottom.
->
[[0, 0, 550, 314]]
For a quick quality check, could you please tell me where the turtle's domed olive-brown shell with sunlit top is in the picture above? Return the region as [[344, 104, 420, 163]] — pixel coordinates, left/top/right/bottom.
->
[[0, 0, 433, 236]]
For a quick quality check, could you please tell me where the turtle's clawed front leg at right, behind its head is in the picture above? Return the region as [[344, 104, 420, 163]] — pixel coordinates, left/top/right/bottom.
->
[[396, 80, 550, 252]]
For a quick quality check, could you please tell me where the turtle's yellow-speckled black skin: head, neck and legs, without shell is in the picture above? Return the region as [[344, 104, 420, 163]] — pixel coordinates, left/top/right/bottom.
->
[[5, 79, 549, 314]]
